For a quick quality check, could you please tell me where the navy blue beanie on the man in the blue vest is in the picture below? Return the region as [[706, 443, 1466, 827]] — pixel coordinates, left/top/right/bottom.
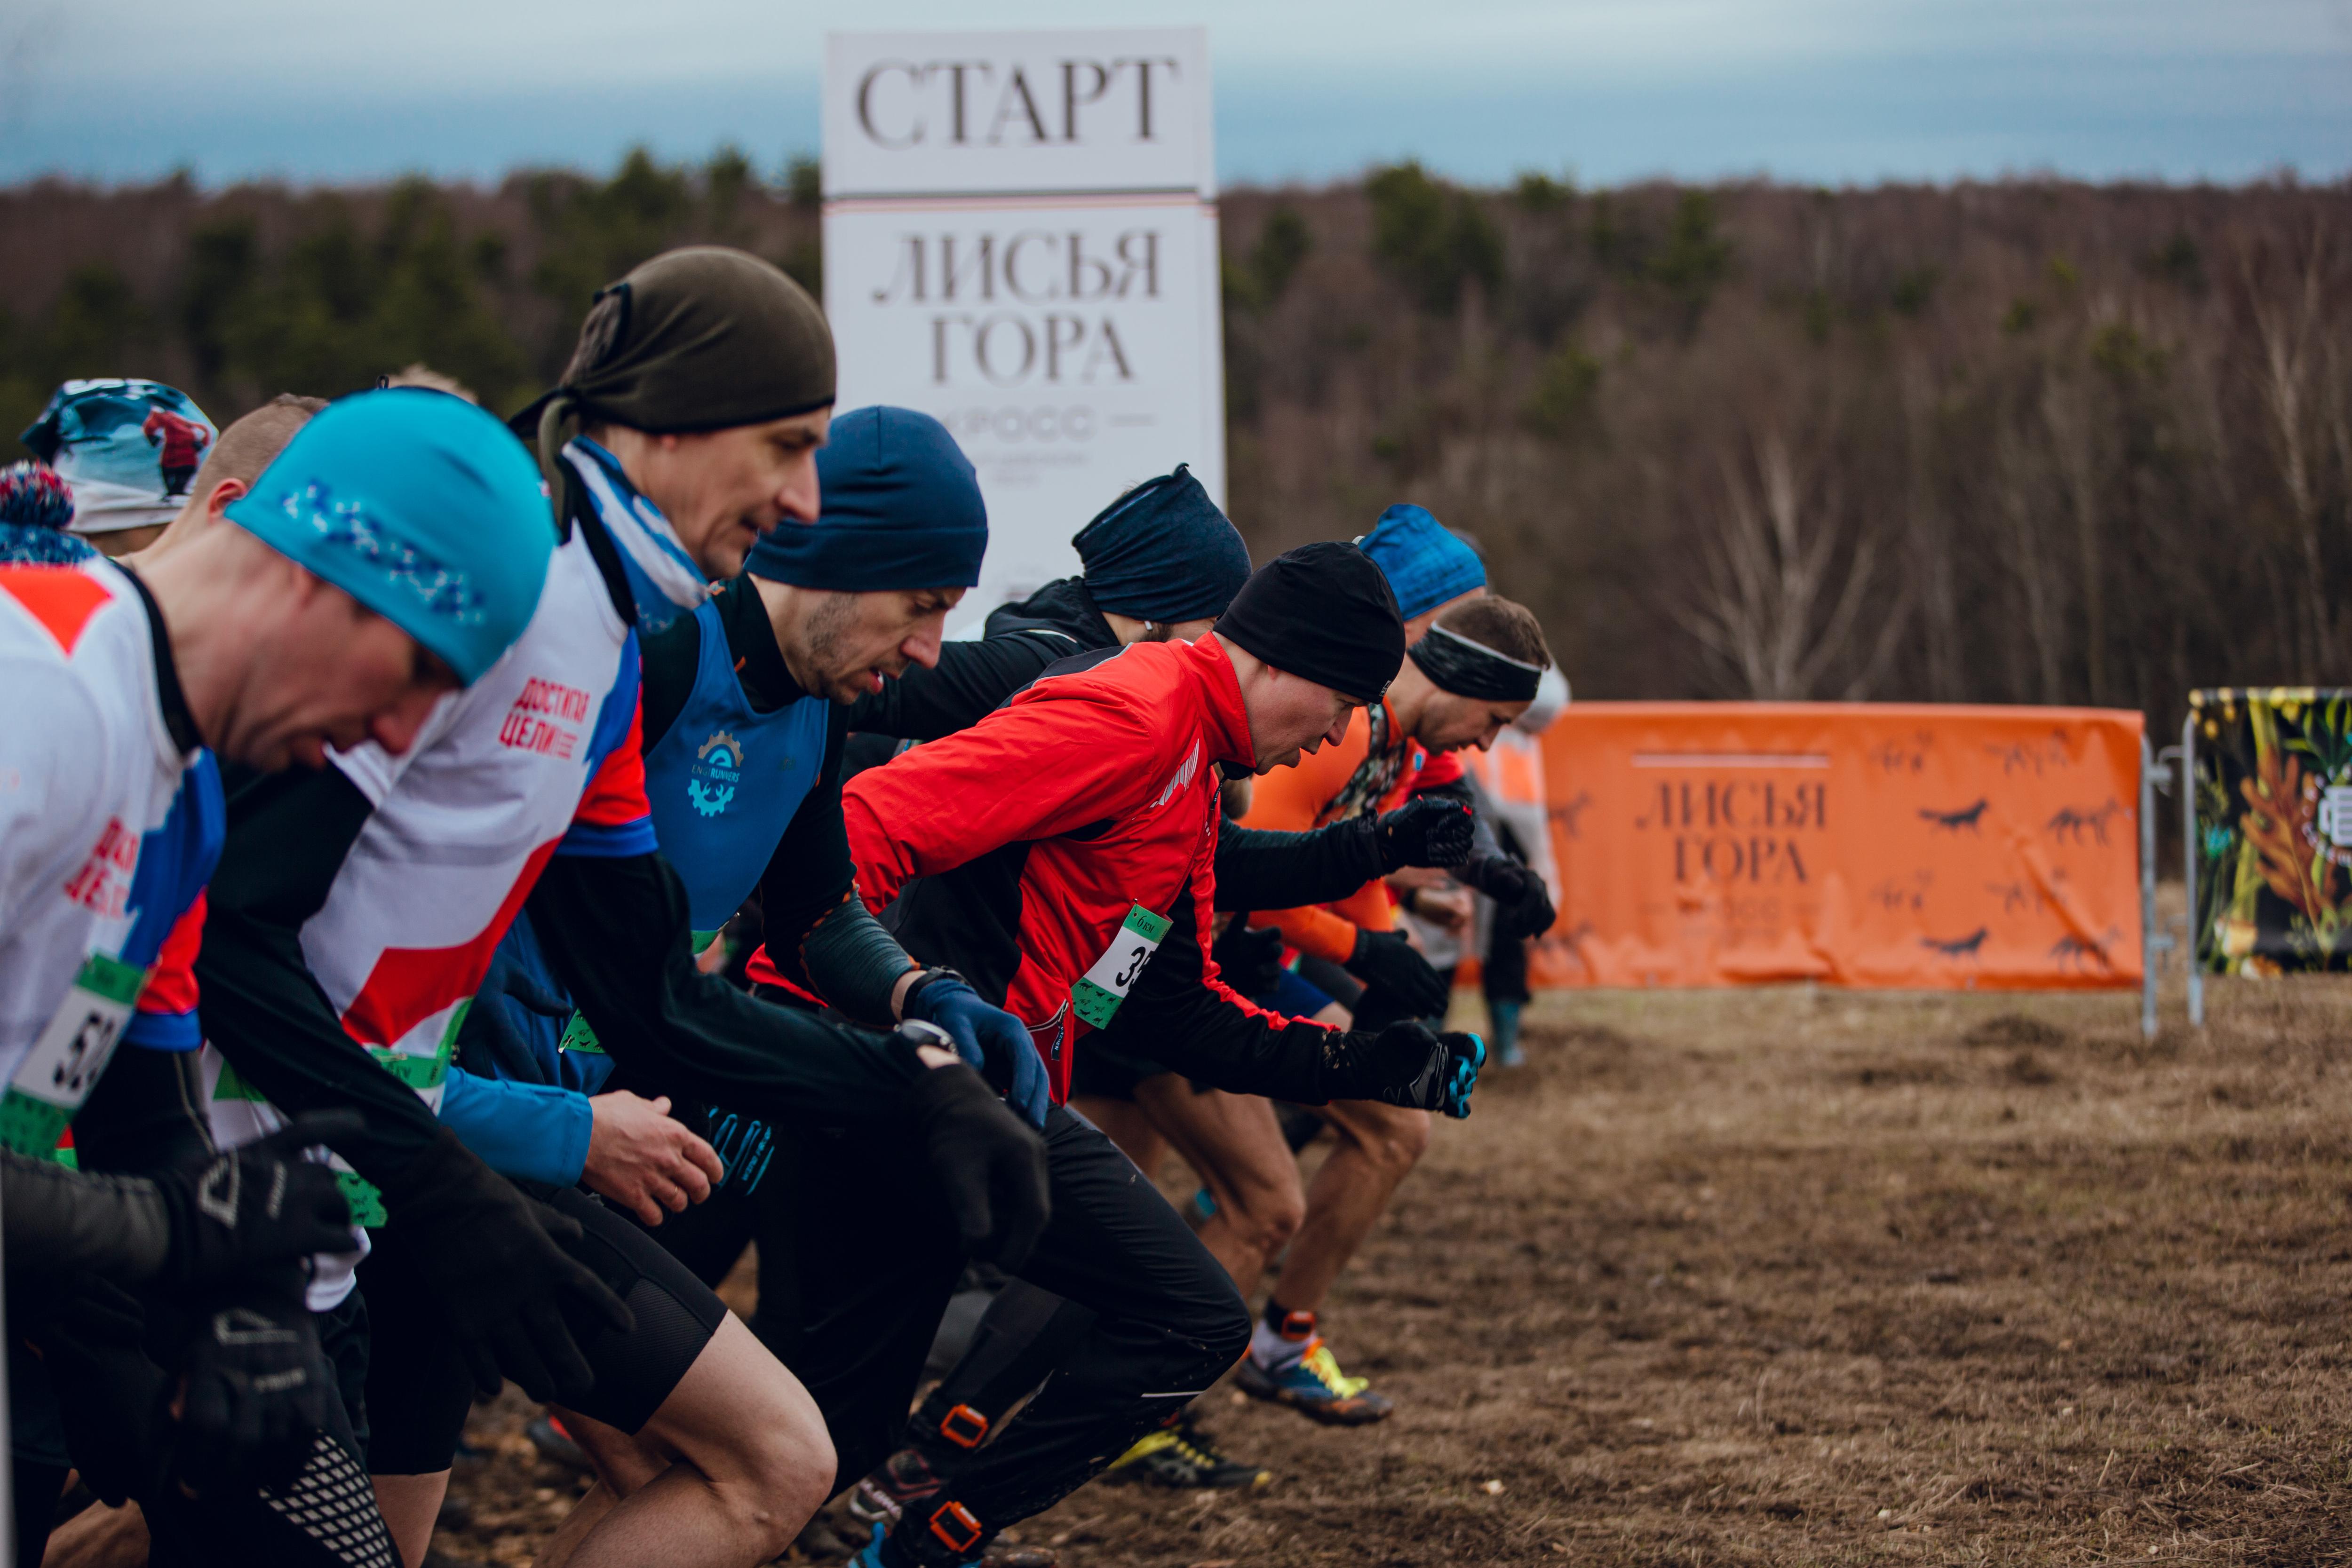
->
[[743, 407, 988, 593]]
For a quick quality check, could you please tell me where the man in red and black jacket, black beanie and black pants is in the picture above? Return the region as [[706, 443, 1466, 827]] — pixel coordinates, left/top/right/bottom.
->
[[818, 546, 1484, 1563]]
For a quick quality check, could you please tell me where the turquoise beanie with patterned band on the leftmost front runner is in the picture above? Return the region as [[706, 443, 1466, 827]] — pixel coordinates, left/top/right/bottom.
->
[[228, 388, 555, 687]]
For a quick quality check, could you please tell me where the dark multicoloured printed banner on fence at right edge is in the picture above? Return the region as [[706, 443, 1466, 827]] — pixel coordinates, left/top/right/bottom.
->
[[2190, 687, 2352, 975]]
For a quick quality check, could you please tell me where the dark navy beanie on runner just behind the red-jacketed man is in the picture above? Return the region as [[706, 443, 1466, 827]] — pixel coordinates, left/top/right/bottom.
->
[[1070, 463, 1249, 626]]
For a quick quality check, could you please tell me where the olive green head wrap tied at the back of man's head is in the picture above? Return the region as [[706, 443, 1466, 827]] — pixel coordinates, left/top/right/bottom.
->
[[515, 245, 833, 480]]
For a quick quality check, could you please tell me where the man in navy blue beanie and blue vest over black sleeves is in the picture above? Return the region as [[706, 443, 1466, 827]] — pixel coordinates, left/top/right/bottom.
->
[[501, 409, 1047, 1533]]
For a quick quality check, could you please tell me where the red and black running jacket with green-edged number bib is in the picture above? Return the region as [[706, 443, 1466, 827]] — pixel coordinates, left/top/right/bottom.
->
[[842, 637, 1376, 1102]]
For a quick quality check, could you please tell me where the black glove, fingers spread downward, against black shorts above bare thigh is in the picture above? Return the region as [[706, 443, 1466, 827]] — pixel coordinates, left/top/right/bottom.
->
[[383, 1128, 637, 1403]]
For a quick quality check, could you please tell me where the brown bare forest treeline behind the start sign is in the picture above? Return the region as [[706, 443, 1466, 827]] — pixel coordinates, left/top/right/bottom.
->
[[0, 153, 2352, 727]]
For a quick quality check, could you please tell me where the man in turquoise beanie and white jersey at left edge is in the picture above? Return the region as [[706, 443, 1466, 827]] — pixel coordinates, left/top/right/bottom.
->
[[0, 380, 546, 1561]]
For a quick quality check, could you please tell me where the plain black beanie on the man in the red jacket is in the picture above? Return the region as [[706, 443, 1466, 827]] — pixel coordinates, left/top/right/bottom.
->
[[1216, 543, 1404, 703]]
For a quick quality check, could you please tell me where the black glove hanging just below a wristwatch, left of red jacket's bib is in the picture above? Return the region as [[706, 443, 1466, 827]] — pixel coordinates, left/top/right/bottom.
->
[[898, 1044, 1054, 1274]]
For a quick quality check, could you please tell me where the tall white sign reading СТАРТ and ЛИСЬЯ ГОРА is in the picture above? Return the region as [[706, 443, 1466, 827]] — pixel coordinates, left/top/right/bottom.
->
[[826, 28, 1225, 628]]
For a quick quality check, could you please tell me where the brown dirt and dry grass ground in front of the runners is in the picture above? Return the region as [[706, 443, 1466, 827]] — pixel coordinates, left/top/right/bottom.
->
[[437, 980, 2352, 1568]]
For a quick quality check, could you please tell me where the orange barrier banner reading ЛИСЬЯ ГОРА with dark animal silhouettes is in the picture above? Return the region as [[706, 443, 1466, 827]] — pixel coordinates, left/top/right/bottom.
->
[[1529, 703, 2143, 990]]
